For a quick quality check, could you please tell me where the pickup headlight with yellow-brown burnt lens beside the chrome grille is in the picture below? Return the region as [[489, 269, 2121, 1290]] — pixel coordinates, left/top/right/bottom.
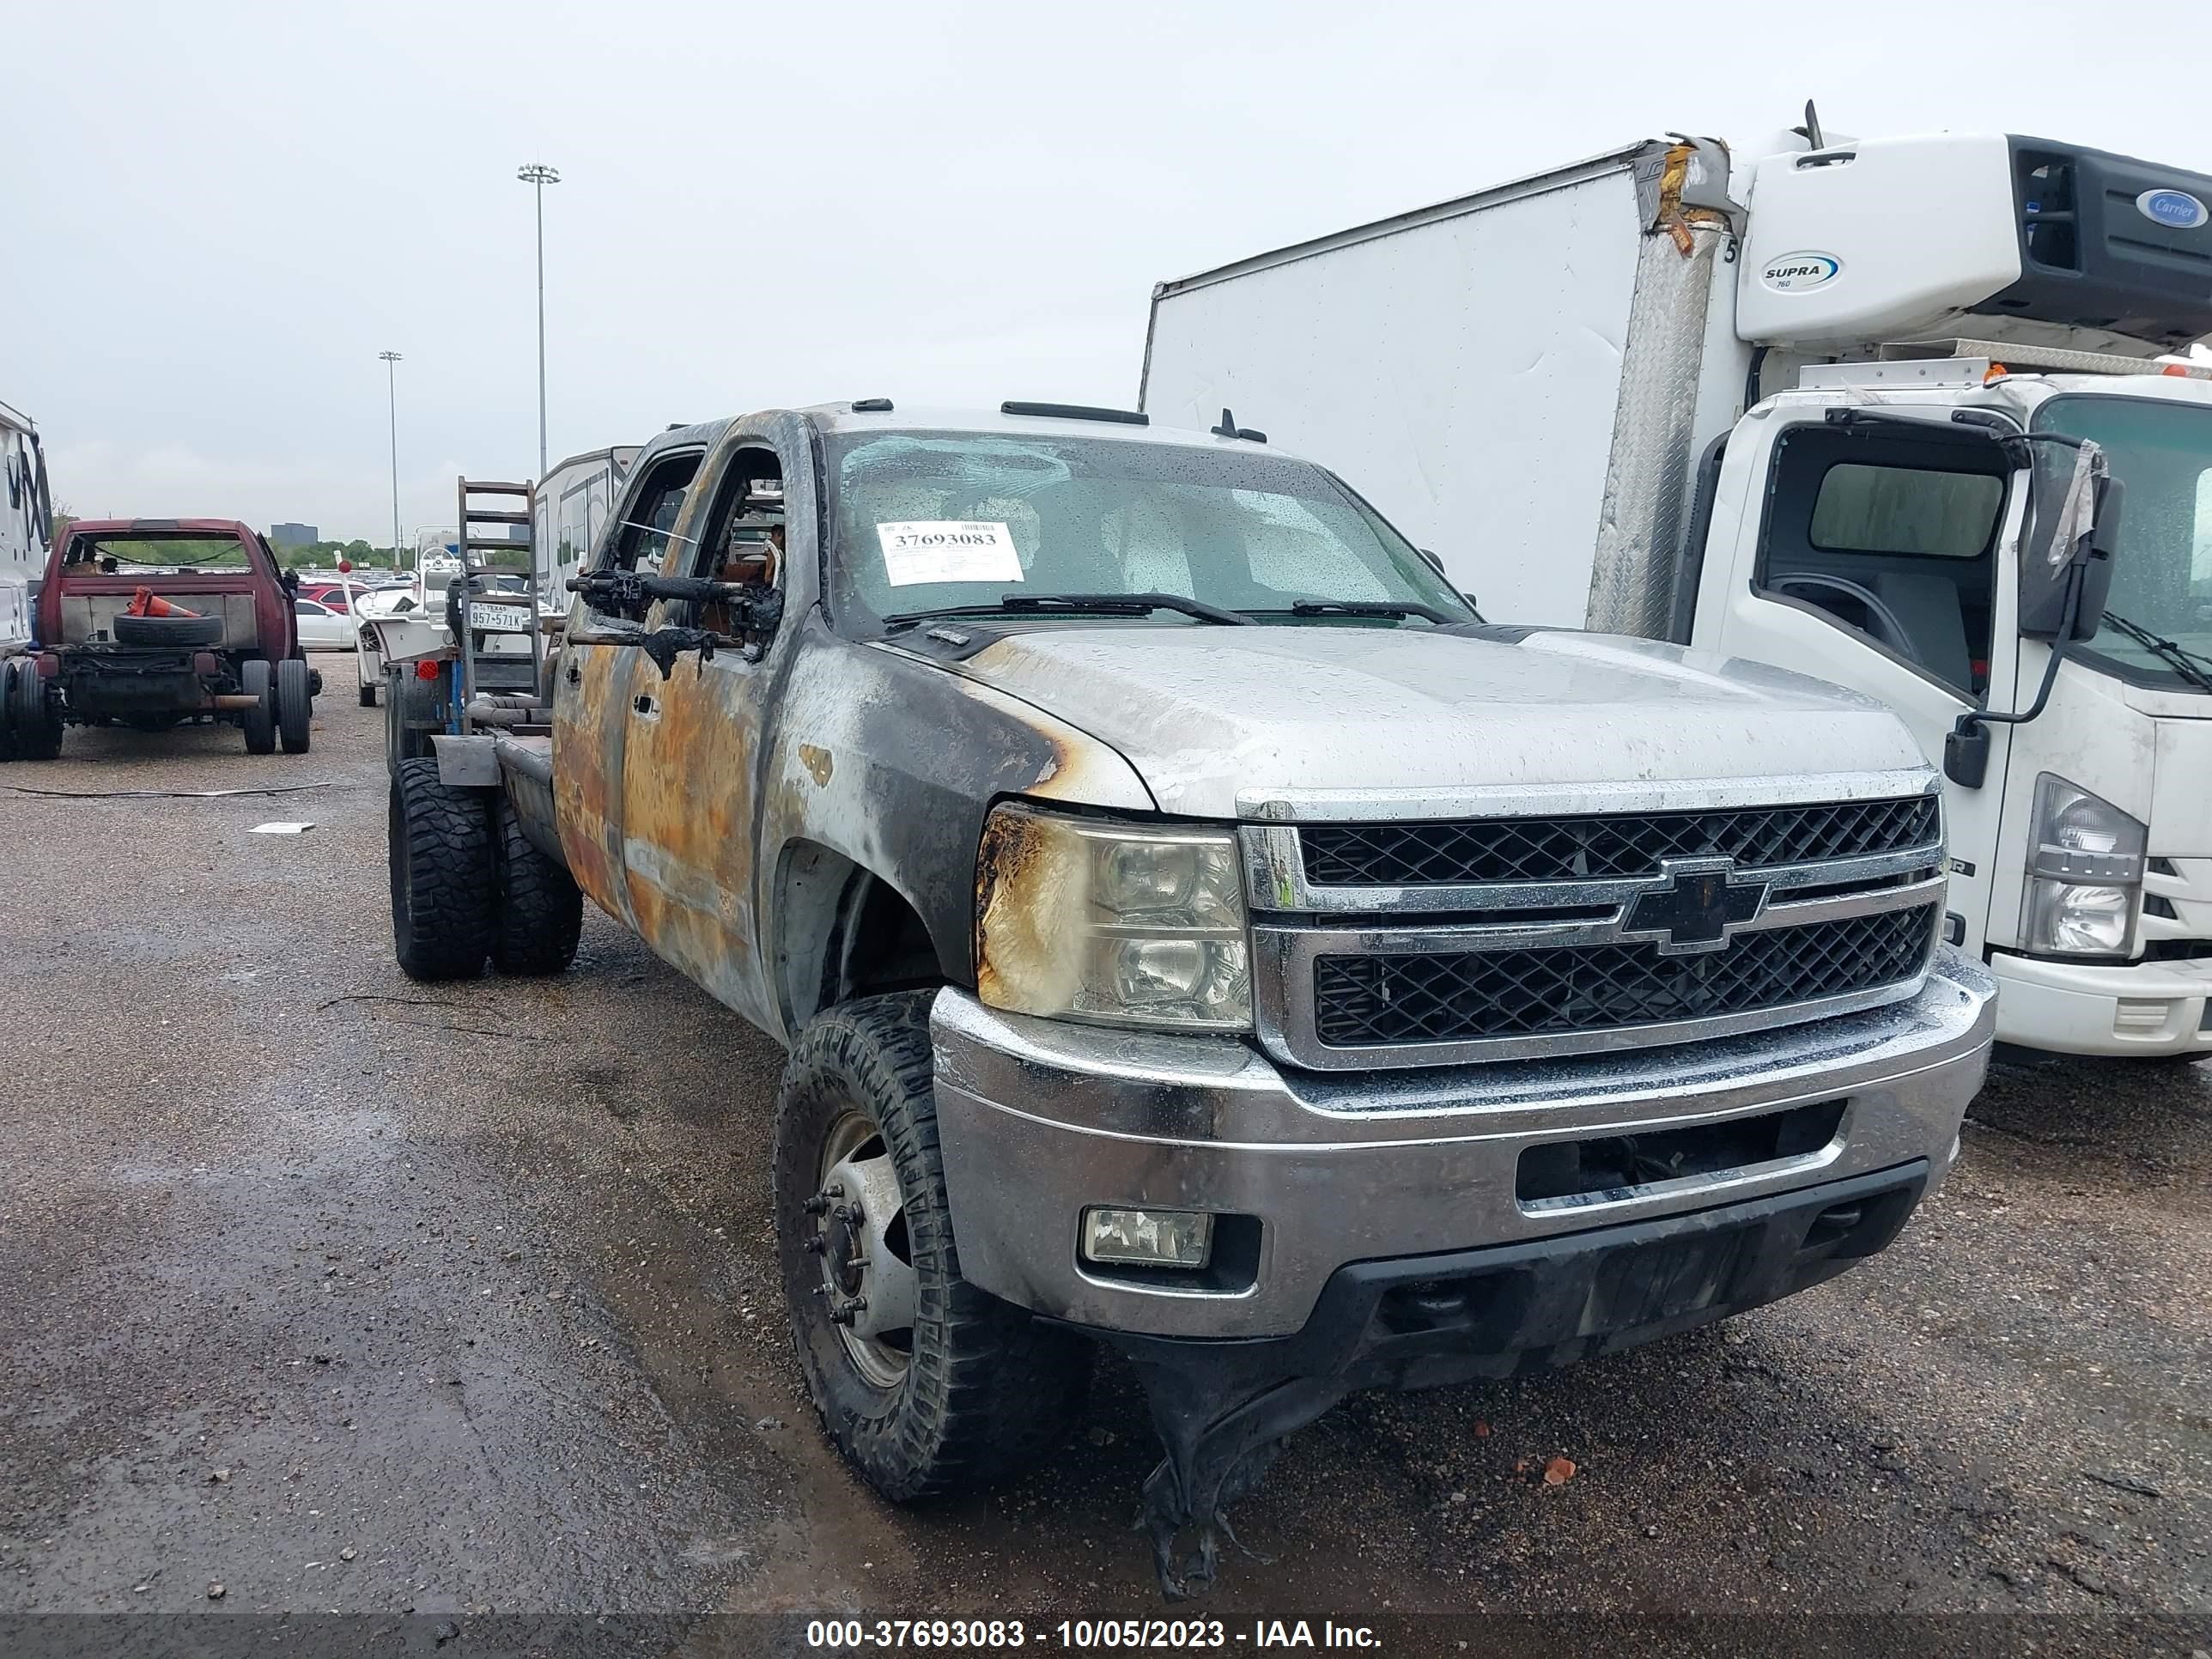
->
[[975, 805, 1252, 1030]]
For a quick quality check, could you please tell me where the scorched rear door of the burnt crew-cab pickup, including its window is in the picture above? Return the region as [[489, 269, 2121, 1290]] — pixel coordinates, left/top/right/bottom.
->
[[553, 447, 706, 925]]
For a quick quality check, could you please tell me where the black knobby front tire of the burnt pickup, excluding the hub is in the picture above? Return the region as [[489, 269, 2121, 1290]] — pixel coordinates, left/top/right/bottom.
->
[[775, 991, 1093, 1502]]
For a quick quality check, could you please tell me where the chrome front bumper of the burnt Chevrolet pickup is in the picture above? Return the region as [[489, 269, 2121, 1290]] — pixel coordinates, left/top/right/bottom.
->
[[931, 949, 1996, 1338]]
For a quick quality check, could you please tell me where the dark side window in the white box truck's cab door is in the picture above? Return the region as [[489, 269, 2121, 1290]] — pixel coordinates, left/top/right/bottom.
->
[[1756, 427, 2006, 696]]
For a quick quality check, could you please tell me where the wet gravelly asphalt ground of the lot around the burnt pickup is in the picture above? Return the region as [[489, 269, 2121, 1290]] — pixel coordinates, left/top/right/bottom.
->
[[0, 671, 2212, 1656]]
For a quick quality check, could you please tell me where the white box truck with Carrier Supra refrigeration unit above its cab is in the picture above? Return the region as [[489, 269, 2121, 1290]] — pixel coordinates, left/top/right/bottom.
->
[[1141, 126, 2212, 1057]]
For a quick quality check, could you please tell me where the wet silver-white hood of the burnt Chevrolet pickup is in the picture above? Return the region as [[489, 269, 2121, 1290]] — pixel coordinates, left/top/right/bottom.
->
[[957, 623, 1927, 818]]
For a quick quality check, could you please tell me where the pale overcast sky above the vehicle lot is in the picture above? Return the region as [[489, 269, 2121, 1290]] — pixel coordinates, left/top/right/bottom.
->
[[13, 0, 2212, 542]]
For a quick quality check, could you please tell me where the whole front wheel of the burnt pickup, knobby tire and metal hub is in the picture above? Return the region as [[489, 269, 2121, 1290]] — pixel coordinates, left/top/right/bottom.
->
[[775, 991, 1091, 1502]]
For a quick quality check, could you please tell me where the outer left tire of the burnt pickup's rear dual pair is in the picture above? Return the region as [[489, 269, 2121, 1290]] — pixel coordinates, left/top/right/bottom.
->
[[385, 759, 493, 980]]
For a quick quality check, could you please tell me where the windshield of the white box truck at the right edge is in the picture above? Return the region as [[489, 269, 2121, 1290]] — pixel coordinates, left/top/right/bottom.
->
[[2037, 396, 2212, 690]]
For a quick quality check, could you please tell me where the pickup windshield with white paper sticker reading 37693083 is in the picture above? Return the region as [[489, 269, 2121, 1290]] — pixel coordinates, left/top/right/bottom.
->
[[825, 431, 1475, 629]]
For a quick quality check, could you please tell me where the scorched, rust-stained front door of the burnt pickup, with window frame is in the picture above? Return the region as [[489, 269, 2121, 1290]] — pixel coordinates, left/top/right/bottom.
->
[[622, 438, 792, 1026]]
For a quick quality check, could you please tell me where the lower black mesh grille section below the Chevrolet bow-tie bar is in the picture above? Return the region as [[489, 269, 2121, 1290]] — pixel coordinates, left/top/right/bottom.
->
[[1314, 905, 1942, 1048]]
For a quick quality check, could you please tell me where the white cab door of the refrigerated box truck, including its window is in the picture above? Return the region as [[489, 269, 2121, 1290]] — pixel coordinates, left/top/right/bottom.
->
[[1694, 411, 2024, 949]]
